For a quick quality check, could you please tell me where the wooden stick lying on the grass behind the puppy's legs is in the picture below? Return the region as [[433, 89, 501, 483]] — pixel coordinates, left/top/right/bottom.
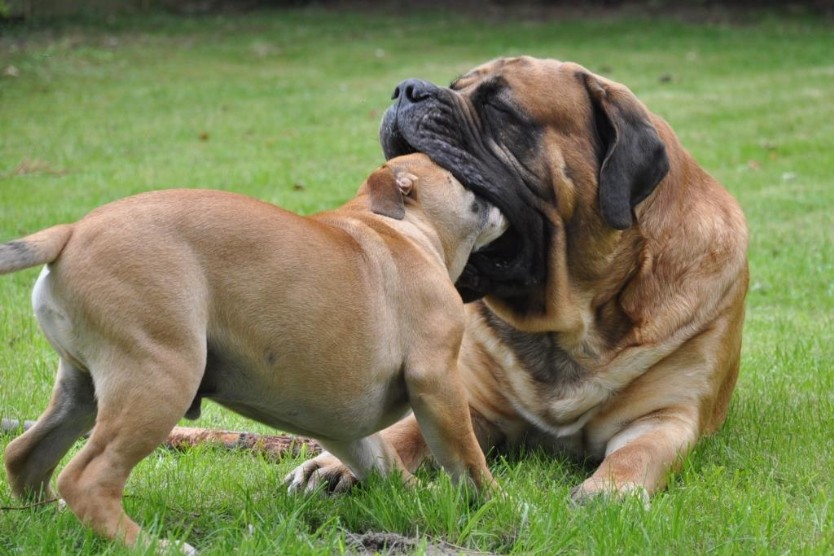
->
[[0, 417, 321, 459]]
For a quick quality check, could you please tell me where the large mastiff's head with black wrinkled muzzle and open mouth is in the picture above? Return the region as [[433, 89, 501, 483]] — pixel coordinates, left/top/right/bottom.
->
[[380, 57, 668, 300]]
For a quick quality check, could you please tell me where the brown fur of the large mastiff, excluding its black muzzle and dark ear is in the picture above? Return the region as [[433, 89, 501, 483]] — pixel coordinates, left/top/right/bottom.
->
[[292, 57, 748, 499]]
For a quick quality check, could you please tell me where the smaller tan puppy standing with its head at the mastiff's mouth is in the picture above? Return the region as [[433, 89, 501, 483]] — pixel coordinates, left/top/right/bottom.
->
[[0, 155, 506, 549]]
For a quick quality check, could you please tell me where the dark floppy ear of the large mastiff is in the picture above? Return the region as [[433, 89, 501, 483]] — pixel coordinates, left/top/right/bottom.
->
[[584, 74, 669, 230]]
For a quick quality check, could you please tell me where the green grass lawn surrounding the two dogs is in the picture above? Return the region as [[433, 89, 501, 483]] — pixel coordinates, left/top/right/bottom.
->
[[0, 5, 834, 554]]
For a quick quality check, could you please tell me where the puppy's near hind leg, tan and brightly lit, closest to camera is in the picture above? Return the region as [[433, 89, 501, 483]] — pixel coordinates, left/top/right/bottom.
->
[[58, 345, 205, 551]]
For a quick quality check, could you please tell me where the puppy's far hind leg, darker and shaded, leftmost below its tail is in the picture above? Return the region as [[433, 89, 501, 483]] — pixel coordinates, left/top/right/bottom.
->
[[4, 359, 96, 500]]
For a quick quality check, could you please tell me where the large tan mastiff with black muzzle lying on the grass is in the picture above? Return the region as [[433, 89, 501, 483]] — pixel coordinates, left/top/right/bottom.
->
[[292, 57, 748, 500]]
